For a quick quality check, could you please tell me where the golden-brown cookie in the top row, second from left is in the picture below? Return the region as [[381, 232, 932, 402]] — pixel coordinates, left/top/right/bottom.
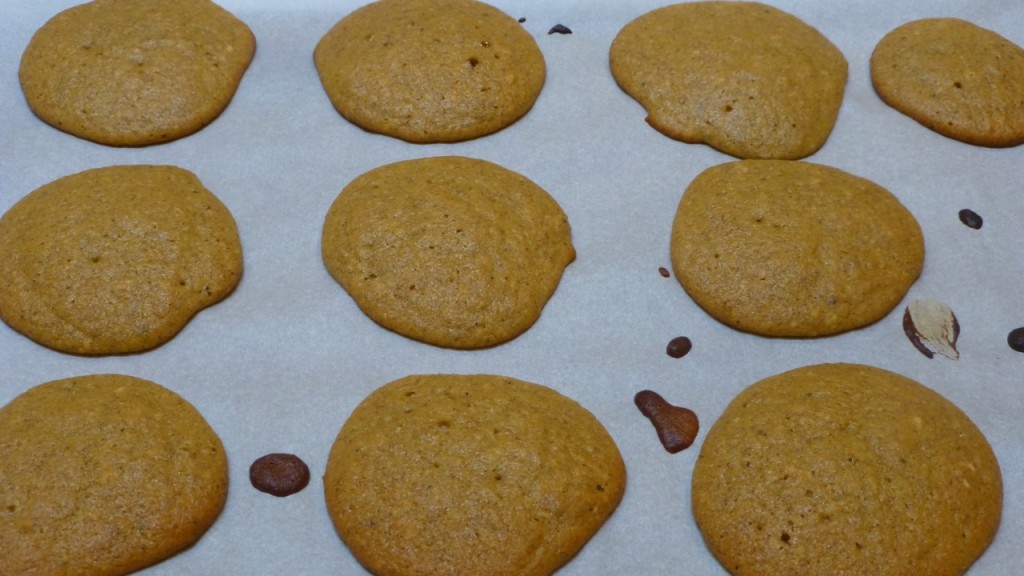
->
[[313, 0, 546, 142]]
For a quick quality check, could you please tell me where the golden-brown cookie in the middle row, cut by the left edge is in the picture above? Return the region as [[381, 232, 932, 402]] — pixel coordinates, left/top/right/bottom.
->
[[0, 165, 242, 355]]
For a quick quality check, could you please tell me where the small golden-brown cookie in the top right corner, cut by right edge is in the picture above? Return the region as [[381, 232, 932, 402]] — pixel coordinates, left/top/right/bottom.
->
[[871, 17, 1024, 147]]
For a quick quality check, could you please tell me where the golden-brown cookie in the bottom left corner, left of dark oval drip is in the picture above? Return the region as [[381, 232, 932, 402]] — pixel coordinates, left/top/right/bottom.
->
[[0, 374, 227, 576]]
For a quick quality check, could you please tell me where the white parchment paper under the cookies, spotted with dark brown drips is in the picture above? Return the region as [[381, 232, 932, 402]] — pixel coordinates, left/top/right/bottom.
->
[[0, 0, 1024, 576]]
